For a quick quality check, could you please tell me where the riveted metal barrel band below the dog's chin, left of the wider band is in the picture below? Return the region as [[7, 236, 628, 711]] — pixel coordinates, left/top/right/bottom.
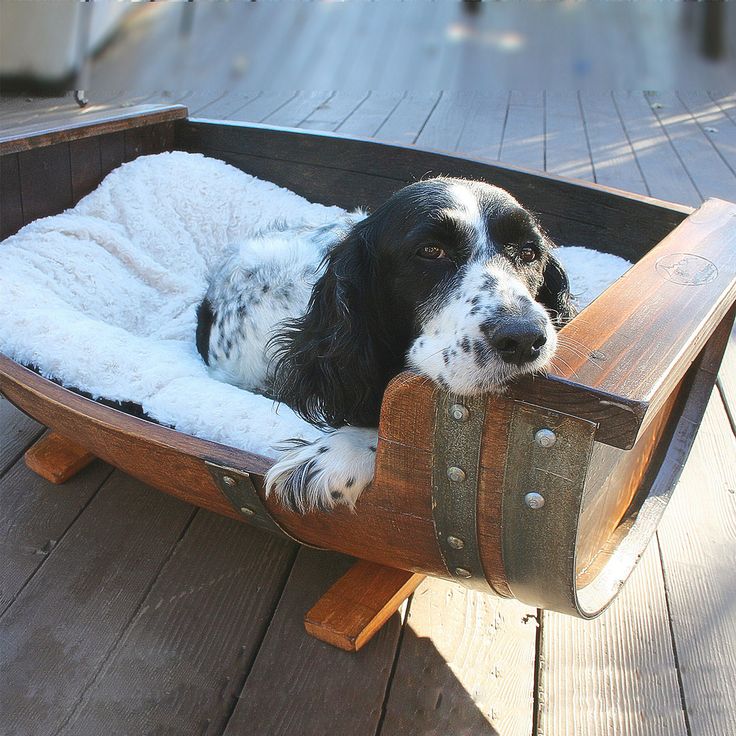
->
[[432, 392, 495, 593]]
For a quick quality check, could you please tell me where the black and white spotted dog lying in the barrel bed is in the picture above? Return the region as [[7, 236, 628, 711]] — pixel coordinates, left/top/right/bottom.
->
[[197, 178, 574, 512]]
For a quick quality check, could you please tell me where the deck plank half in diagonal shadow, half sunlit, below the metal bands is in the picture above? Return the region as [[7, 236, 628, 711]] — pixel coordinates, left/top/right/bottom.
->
[[381, 579, 537, 736]]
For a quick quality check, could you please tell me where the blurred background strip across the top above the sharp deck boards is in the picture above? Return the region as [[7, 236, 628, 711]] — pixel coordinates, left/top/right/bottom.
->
[[0, 0, 736, 100]]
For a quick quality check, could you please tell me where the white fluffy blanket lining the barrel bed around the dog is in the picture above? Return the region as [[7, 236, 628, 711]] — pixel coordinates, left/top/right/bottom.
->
[[0, 152, 630, 455]]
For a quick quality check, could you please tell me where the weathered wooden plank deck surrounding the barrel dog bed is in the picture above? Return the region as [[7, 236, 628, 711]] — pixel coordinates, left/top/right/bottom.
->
[[0, 5, 736, 736]]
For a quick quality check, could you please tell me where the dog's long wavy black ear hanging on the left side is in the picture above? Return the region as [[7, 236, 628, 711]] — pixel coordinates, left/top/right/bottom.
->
[[273, 221, 386, 427]]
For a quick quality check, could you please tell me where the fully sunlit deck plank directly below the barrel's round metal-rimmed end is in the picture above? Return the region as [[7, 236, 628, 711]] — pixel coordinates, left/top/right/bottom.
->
[[537, 543, 688, 736]]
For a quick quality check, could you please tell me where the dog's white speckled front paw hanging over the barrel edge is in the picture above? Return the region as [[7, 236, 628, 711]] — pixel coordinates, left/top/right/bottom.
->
[[266, 427, 378, 514]]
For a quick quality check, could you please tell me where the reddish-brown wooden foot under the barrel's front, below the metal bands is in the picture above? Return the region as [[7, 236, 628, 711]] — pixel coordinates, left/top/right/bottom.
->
[[304, 560, 425, 652]]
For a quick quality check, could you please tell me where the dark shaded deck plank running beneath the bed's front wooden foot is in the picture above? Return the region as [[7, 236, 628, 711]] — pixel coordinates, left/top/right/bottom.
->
[[225, 548, 401, 736]]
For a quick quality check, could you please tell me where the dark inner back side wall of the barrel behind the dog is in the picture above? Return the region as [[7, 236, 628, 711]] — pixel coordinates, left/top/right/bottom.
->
[[178, 118, 691, 260]]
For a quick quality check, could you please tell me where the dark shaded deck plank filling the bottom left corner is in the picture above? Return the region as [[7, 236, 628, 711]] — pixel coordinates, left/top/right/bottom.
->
[[0, 474, 194, 734]]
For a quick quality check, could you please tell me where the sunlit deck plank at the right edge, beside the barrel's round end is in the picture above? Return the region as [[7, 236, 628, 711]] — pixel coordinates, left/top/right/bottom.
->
[[658, 391, 736, 736]]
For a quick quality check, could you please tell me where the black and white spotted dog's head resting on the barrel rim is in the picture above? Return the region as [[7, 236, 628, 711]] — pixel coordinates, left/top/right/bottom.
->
[[276, 178, 574, 426]]
